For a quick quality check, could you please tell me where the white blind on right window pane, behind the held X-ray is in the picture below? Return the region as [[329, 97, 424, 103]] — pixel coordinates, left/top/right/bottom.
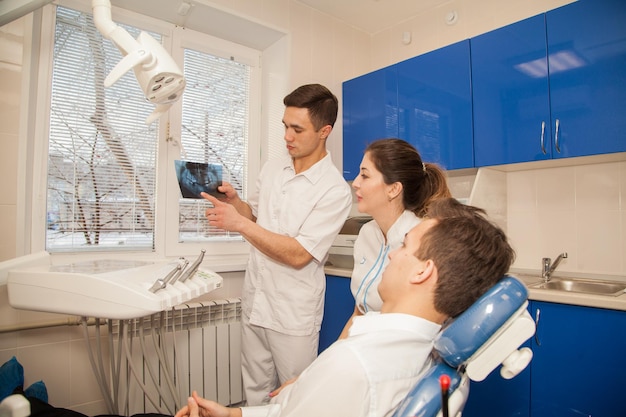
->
[[179, 49, 250, 242]]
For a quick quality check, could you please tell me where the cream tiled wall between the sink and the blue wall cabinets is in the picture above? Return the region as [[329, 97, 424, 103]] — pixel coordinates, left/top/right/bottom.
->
[[507, 162, 626, 276]]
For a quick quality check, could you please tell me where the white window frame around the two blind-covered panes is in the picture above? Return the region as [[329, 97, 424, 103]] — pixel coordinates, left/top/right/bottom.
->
[[24, 0, 262, 270]]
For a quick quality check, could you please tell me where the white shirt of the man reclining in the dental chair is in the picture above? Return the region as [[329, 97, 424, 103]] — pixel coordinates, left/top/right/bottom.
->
[[242, 312, 441, 417]]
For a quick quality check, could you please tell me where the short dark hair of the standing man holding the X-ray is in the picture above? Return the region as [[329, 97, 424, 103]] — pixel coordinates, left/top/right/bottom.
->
[[283, 84, 339, 130]]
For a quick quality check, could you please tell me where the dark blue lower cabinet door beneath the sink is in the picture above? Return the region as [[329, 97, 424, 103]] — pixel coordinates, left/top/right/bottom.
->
[[530, 301, 626, 417]]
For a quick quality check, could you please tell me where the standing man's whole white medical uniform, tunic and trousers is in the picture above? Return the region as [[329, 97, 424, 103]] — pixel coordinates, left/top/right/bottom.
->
[[242, 154, 352, 405]]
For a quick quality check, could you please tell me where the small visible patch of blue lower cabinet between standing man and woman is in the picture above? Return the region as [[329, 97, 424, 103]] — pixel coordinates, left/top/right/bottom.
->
[[319, 275, 354, 353]]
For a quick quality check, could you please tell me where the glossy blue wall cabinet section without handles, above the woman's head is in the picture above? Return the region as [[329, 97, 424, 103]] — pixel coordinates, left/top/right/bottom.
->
[[343, 41, 474, 175]]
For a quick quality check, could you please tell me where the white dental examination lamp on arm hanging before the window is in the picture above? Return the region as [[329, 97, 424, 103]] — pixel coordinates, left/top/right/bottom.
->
[[91, 0, 185, 124]]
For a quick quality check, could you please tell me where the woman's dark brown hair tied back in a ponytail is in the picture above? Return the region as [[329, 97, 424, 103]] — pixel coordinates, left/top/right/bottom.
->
[[365, 138, 452, 217]]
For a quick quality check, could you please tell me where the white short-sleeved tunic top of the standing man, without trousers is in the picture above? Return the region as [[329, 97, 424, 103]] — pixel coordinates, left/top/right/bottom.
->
[[242, 154, 352, 336]]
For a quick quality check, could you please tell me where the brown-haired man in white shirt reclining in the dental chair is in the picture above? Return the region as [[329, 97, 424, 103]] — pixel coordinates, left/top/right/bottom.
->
[[175, 199, 514, 417]]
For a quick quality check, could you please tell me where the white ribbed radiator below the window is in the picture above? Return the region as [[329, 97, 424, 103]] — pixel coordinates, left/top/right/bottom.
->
[[85, 298, 244, 415]]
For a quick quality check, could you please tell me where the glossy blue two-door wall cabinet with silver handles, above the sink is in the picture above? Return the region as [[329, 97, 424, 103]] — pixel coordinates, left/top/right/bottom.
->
[[470, 0, 626, 167]]
